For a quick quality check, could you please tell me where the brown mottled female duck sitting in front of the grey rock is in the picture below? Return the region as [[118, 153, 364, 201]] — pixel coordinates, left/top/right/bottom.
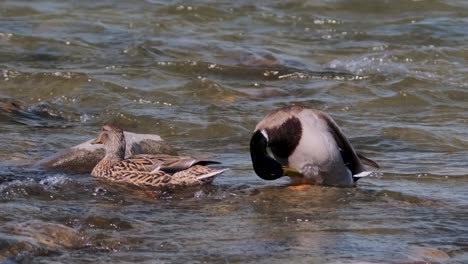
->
[[91, 125, 225, 187]]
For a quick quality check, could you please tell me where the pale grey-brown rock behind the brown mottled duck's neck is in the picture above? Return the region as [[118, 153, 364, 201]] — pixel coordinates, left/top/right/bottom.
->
[[36, 132, 177, 173]]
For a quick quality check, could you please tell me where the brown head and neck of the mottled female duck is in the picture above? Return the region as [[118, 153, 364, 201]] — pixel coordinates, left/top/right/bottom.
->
[[91, 125, 125, 159]]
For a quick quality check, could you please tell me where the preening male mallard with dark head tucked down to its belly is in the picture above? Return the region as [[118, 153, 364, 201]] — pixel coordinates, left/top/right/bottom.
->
[[250, 106, 379, 186]]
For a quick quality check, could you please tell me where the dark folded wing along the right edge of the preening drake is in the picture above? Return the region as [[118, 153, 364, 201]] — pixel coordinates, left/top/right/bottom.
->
[[317, 112, 378, 177]]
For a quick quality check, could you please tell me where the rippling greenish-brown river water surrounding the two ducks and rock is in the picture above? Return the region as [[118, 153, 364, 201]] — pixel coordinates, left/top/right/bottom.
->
[[0, 0, 468, 263]]
